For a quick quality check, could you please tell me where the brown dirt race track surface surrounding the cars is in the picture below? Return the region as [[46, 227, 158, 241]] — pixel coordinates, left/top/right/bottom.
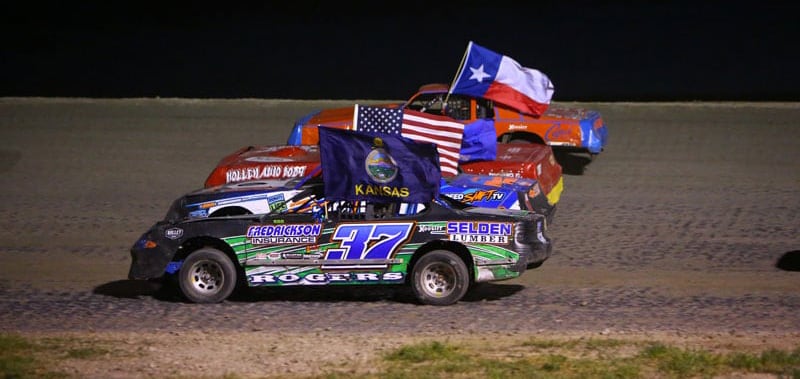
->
[[0, 98, 800, 377]]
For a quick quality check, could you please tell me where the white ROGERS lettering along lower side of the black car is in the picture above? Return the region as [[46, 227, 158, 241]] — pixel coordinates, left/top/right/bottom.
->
[[248, 272, 404, 284]]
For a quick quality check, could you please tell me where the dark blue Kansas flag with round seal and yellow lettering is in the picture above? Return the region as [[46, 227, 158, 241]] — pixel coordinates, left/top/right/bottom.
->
[[319, 127, 441, 203]]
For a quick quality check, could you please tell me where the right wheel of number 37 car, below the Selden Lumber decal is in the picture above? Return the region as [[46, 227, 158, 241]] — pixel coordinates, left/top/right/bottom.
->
[[411, 250, 470, 305]]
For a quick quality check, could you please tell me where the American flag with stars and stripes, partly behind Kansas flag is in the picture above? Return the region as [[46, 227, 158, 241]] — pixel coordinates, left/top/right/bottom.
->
[[353, 104, 464, 177]]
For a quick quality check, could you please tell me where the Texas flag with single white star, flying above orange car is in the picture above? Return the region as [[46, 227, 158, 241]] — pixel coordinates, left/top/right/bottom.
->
[[450, 41, 554, 115]]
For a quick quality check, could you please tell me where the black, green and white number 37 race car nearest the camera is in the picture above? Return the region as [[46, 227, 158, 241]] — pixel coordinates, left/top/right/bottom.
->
[[128, 178, 552, 305]]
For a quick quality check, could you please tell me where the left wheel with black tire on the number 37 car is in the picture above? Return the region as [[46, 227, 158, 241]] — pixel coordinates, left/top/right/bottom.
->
[[178, 247, 237, 303]]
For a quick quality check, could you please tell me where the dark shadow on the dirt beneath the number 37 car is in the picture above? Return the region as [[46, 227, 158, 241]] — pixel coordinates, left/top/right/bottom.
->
[[93, 280, 524, 304]]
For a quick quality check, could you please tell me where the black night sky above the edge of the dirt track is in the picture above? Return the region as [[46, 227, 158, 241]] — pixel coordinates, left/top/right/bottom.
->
[[0, 1, 800, 101]]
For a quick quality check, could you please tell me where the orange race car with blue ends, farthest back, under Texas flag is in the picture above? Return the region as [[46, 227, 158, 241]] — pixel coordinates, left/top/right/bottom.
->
[[287, 84, 608, 157]]
